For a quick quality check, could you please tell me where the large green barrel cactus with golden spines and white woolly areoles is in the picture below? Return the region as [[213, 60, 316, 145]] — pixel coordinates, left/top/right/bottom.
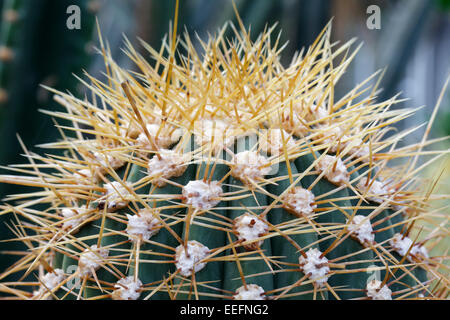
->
[[0, 18, 448, 300]]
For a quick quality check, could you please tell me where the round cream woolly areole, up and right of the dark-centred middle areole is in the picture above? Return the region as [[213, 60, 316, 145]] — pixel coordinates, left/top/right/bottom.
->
[[282, 187, 317, 217]]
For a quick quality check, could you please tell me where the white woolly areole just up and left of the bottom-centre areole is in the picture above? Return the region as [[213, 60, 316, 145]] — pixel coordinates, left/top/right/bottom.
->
[[175, 240, 209, 277]]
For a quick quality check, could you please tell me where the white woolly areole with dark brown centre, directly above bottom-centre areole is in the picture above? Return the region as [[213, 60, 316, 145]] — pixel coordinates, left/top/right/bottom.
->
[[233, 213, 269, 250]]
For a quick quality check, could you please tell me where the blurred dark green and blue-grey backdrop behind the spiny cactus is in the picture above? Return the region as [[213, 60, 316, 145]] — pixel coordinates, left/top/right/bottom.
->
[[0, 0, 450, 282]]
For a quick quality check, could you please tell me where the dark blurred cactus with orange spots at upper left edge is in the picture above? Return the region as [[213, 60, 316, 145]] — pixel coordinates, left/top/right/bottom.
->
[[0, 0, 96, 280]]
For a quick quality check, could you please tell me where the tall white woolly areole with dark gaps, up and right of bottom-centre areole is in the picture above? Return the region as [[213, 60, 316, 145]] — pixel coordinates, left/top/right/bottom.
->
[[299, 248, 330, 286]]
